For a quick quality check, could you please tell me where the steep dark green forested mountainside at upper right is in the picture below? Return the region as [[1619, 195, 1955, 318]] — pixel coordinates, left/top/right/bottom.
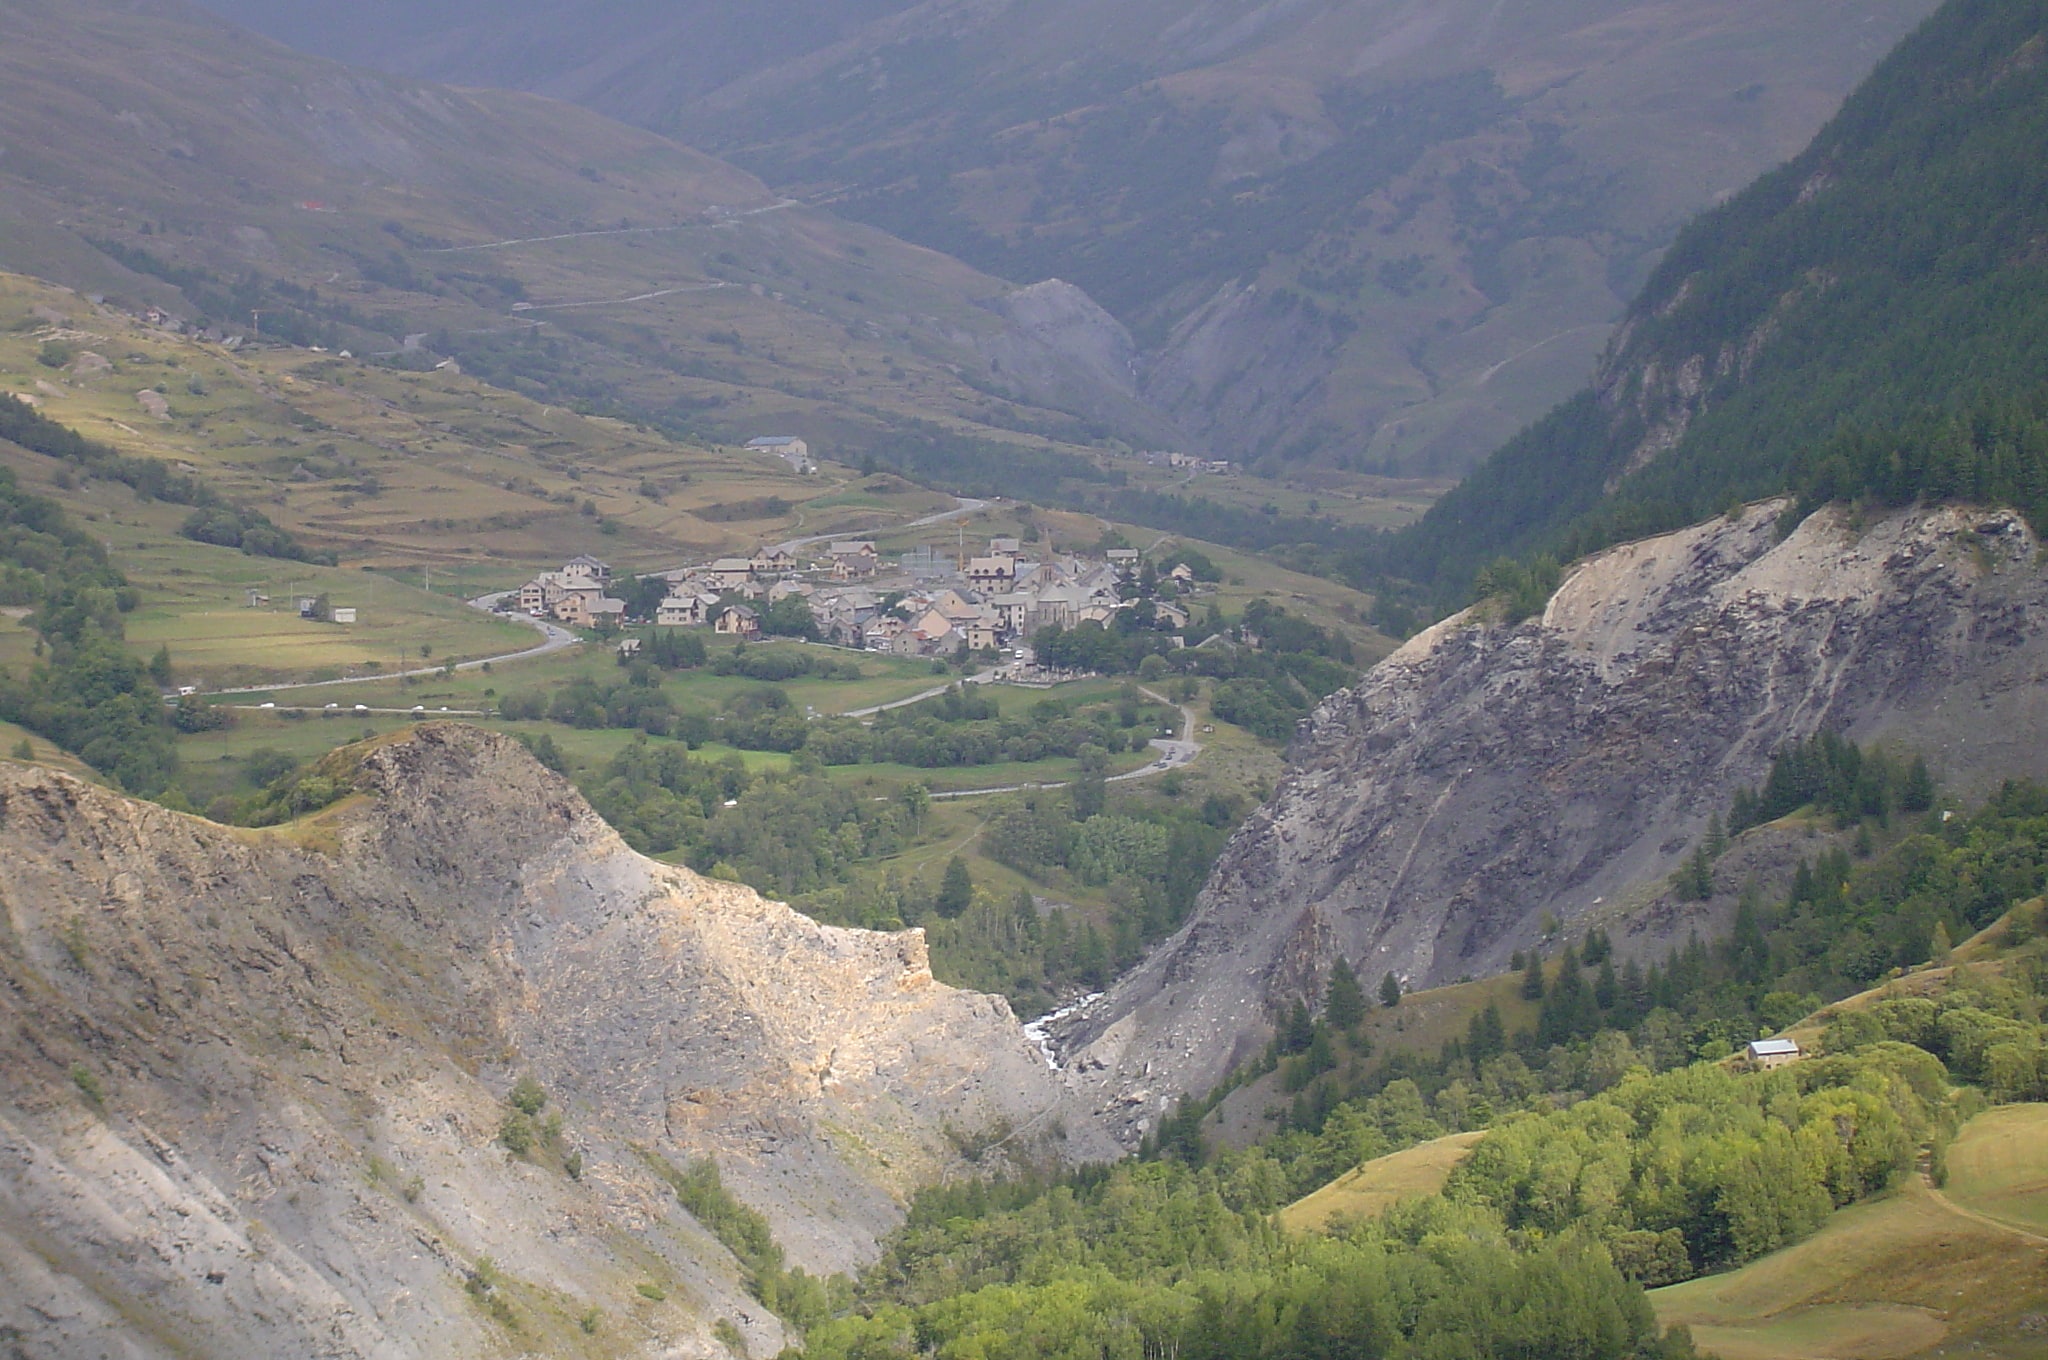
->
[[1389, 0, 2048, 592]]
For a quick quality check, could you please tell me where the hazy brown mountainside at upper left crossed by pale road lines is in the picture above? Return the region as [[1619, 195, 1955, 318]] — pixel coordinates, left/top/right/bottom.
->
[[0, 0, 1187, 466]]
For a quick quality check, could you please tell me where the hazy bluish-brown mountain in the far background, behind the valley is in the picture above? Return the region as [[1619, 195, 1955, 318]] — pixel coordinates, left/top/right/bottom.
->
[[219, 0, 1931, 469]]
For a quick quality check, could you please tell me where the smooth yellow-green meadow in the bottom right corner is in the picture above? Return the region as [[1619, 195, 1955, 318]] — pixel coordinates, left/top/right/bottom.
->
[[1651, 1106, 2048, 1360]]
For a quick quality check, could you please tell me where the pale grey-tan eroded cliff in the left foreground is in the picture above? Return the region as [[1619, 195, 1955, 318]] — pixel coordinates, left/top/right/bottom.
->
[[0, 725, 1106, 1356]]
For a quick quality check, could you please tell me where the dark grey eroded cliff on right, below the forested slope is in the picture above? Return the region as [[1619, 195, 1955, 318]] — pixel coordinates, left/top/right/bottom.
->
[[1063, 504, 2048, 1139]]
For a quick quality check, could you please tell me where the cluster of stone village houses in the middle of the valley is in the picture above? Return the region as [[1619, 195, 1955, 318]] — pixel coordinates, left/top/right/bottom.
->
[[504, 537, 1200, 657]]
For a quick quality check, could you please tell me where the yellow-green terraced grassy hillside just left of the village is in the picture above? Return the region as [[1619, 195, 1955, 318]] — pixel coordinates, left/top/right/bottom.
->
[[0, 277, 948, 696]]
